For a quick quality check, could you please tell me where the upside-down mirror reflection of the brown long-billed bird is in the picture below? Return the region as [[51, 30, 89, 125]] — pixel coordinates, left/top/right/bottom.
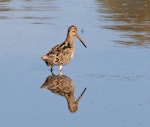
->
[[41, 73, 86, 112]]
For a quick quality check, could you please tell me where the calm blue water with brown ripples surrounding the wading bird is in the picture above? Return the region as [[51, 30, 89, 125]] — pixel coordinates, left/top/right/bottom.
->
[[0, 0, 150, 127]]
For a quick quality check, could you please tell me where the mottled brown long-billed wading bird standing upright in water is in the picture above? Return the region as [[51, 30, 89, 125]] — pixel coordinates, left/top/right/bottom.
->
[[41, 26, 86, 71]]
